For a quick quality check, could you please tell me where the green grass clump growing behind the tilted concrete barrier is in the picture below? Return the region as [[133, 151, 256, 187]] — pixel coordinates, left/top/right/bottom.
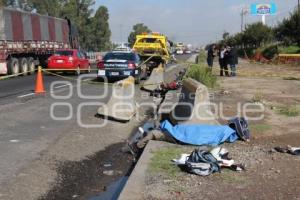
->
[[186, 64, 217, 88]]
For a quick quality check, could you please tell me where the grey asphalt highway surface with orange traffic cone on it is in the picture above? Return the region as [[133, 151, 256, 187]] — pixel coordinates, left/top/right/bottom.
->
[[0, 55, 195, 200]]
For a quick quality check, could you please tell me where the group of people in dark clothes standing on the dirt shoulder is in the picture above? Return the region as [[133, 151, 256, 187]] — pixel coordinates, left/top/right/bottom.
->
[[207, 45, 238, 76]]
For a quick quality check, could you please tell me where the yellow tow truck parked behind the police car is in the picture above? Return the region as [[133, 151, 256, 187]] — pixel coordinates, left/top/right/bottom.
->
[[133, 33, 170, 73]]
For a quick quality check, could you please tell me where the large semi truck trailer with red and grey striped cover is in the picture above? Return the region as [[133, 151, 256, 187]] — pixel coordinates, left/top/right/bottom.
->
[[0, 8, 79, 75]]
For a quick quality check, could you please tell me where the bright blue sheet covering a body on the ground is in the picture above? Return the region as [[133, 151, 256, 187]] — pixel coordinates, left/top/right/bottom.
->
[[160, 120, 238, 146]]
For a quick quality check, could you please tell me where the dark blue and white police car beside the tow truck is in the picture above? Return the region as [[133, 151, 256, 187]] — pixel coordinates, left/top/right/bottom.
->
[[97, 51, 147, 84]]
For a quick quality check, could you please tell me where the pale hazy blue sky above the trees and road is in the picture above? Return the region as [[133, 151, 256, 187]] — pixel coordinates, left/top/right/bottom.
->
[[94, 0, 297, 46]]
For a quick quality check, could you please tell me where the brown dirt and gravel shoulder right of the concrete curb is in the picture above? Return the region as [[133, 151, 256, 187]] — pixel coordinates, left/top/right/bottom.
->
[[144, 61, 300, 199]]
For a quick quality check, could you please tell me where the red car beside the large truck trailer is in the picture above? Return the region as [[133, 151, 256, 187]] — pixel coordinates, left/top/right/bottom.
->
[[48, 49, 91, 75]]
